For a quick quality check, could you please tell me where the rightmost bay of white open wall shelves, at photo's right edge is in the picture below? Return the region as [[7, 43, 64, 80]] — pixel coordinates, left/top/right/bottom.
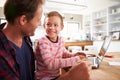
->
[[108, 4, 120, 40]]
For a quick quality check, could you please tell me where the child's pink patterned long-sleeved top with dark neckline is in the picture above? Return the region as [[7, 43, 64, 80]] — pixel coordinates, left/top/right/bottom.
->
[[35, 36, 80, 80]]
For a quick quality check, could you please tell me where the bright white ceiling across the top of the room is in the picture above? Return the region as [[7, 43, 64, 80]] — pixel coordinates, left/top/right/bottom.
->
[[0, 0, 120, 14]]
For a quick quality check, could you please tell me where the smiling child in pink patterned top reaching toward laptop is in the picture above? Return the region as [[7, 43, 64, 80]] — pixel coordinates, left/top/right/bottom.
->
[[36, 11, 86, 80]]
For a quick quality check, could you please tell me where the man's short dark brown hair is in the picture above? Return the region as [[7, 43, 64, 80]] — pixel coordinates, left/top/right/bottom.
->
[[4, 0, 45, 23]]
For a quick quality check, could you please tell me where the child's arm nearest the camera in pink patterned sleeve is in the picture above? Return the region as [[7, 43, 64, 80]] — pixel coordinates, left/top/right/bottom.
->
[[36, 41, 80, 69]]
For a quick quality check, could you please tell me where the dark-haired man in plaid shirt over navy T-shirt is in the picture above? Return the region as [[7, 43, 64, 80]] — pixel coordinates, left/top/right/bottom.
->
[[0, 0, 89, 80]]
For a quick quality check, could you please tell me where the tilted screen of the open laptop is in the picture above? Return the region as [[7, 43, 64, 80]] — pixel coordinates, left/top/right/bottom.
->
[[99, 36, 112, 57]]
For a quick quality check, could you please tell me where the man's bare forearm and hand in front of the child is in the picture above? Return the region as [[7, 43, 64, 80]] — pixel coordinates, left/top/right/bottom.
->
[[59, 61, 91, 80]]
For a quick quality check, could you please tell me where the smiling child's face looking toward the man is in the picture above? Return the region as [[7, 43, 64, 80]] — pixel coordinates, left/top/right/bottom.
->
[[44, 16, 63, 40]]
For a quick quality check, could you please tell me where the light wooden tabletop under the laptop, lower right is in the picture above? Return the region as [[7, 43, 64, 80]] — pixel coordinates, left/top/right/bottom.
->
[[61, 52, 120, 80]]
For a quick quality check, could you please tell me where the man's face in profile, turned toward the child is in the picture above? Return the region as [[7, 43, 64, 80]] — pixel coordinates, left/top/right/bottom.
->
[[22, 5, 43, 36]]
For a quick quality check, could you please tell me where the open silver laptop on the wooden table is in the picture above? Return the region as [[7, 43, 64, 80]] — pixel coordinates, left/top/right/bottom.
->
[[87, 36, 112, 69]]
